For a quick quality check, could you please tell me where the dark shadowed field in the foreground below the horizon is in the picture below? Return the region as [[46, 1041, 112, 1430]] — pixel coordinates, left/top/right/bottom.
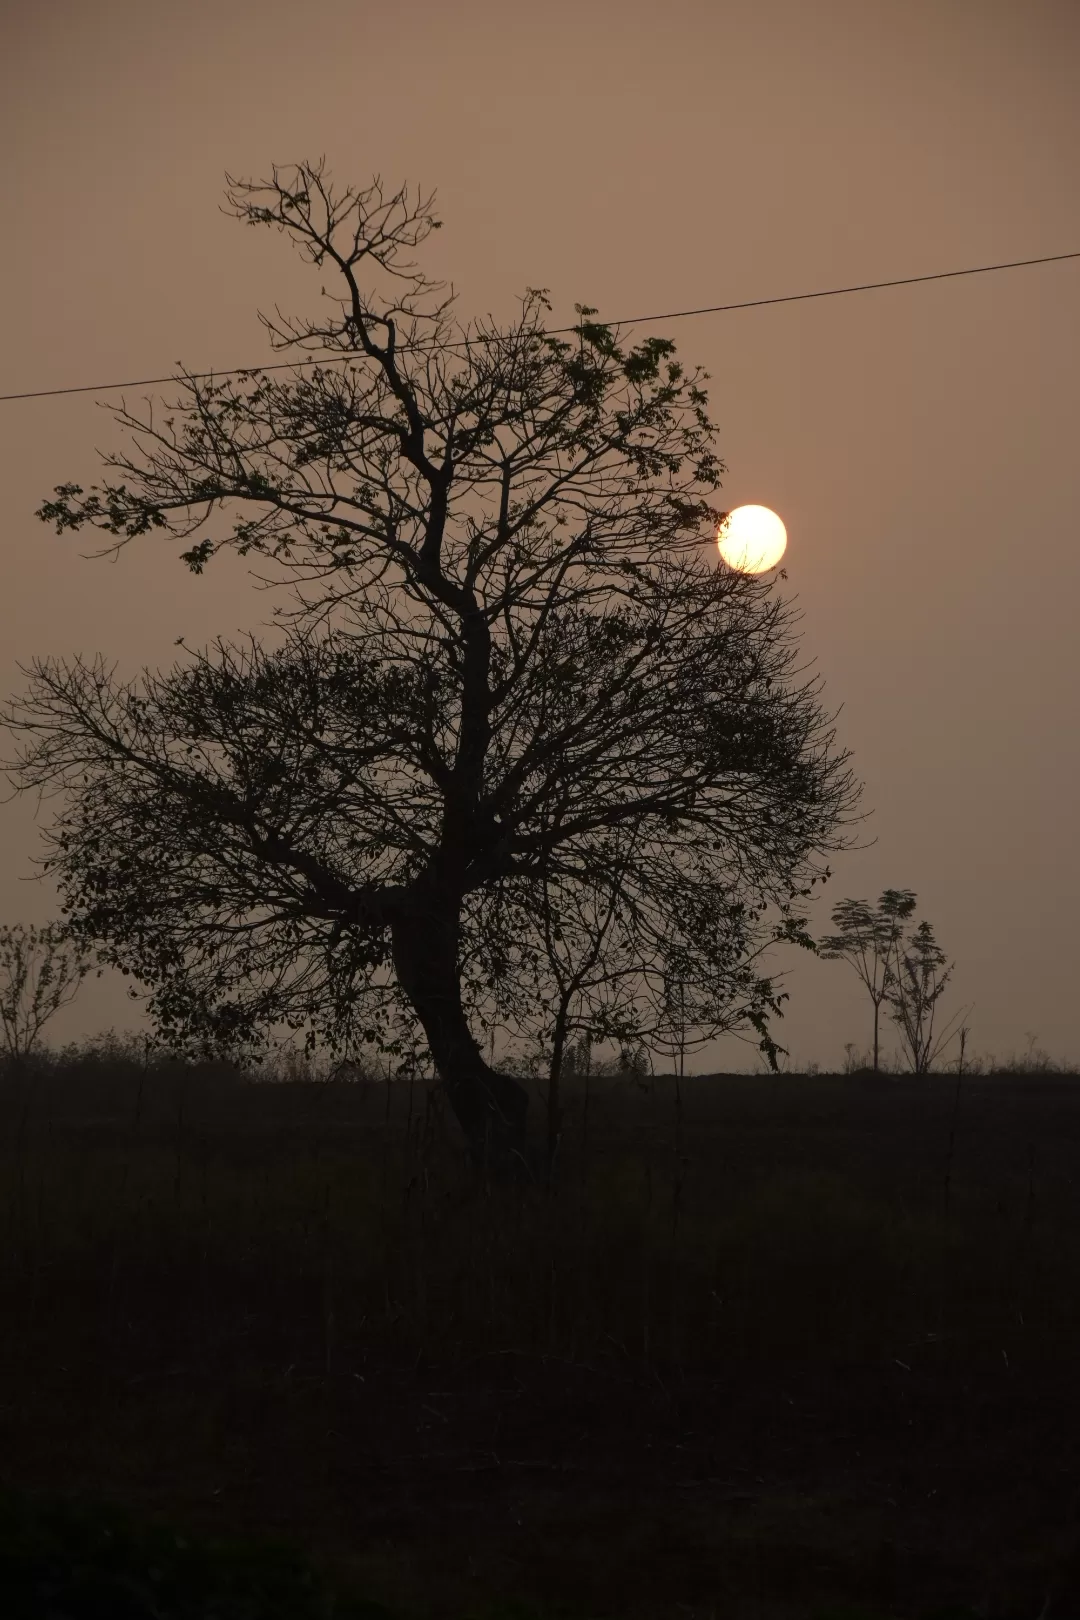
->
[[0, 1068, 1080, 1620]]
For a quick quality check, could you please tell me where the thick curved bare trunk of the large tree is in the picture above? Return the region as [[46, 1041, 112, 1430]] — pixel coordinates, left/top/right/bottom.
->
[[392, 891, 539, 1183]]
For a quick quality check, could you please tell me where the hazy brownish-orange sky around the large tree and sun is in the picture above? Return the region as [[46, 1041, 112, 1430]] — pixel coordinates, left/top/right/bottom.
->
[[0, 0, 1080, 1069]]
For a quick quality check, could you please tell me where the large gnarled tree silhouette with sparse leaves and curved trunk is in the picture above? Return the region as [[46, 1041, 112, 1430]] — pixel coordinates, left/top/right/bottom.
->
[[5, 162, 858, 1170]]
